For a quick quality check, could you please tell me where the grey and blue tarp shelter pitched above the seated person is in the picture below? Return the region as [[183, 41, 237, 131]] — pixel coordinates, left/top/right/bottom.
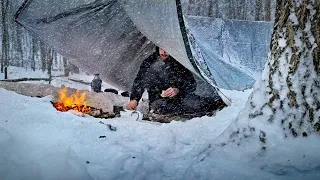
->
[[15, 0, 272, 96]]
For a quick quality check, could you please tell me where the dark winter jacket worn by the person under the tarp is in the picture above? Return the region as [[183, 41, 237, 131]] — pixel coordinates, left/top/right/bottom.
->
[[130, 53, 196, 103]]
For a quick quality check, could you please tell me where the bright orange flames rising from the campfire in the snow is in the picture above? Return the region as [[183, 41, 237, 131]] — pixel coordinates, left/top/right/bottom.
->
[[54, 88, 91, 113]]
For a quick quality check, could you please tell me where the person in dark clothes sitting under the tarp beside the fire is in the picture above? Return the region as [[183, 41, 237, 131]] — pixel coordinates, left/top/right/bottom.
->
[[126, 48, 226, 114]]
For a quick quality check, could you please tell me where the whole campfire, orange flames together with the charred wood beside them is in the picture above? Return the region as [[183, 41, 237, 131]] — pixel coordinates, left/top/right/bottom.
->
[[52, 87, 120, 118]]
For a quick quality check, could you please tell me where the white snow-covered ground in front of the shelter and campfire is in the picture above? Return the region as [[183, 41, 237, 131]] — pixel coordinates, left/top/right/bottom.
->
[[0, 70, 320, 180]]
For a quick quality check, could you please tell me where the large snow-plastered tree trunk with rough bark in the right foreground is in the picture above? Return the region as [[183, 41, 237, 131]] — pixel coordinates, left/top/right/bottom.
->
[[231, 0, 320, 149]]
